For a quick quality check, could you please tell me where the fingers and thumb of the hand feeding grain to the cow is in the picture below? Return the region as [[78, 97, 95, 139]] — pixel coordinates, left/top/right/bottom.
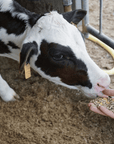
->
[[88, 89, 114, 119]]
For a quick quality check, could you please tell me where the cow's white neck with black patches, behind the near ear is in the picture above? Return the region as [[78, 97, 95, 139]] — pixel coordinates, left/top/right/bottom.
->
[[0, 27, 31, 61]]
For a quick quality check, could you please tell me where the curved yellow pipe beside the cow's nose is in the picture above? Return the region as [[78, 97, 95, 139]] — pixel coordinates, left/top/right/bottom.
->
[[88, 34, 114, 75]]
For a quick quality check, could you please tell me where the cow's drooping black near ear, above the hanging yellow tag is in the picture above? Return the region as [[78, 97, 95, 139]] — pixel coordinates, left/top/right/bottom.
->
[[19, 41, 38, 71]]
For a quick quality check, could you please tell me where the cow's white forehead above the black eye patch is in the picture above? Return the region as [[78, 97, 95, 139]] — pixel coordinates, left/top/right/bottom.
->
[[36, 11, 85, 48]]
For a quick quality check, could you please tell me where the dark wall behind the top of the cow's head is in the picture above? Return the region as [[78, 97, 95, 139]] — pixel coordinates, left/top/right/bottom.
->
[[16, 0, 75, 14]]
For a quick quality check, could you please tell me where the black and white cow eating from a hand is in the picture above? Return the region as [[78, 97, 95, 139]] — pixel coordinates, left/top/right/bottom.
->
[[0, 0, 110, 101]]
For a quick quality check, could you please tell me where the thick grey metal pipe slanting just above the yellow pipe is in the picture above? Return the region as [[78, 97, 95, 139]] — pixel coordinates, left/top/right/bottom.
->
[[86, 25, 114, 49]]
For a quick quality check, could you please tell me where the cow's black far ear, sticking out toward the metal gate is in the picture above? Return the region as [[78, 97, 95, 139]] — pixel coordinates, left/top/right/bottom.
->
[[62, 9, 87, 24]]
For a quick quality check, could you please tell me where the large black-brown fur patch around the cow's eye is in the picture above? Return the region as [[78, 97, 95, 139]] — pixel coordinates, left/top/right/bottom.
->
[[35, 40, 92, 88]]
